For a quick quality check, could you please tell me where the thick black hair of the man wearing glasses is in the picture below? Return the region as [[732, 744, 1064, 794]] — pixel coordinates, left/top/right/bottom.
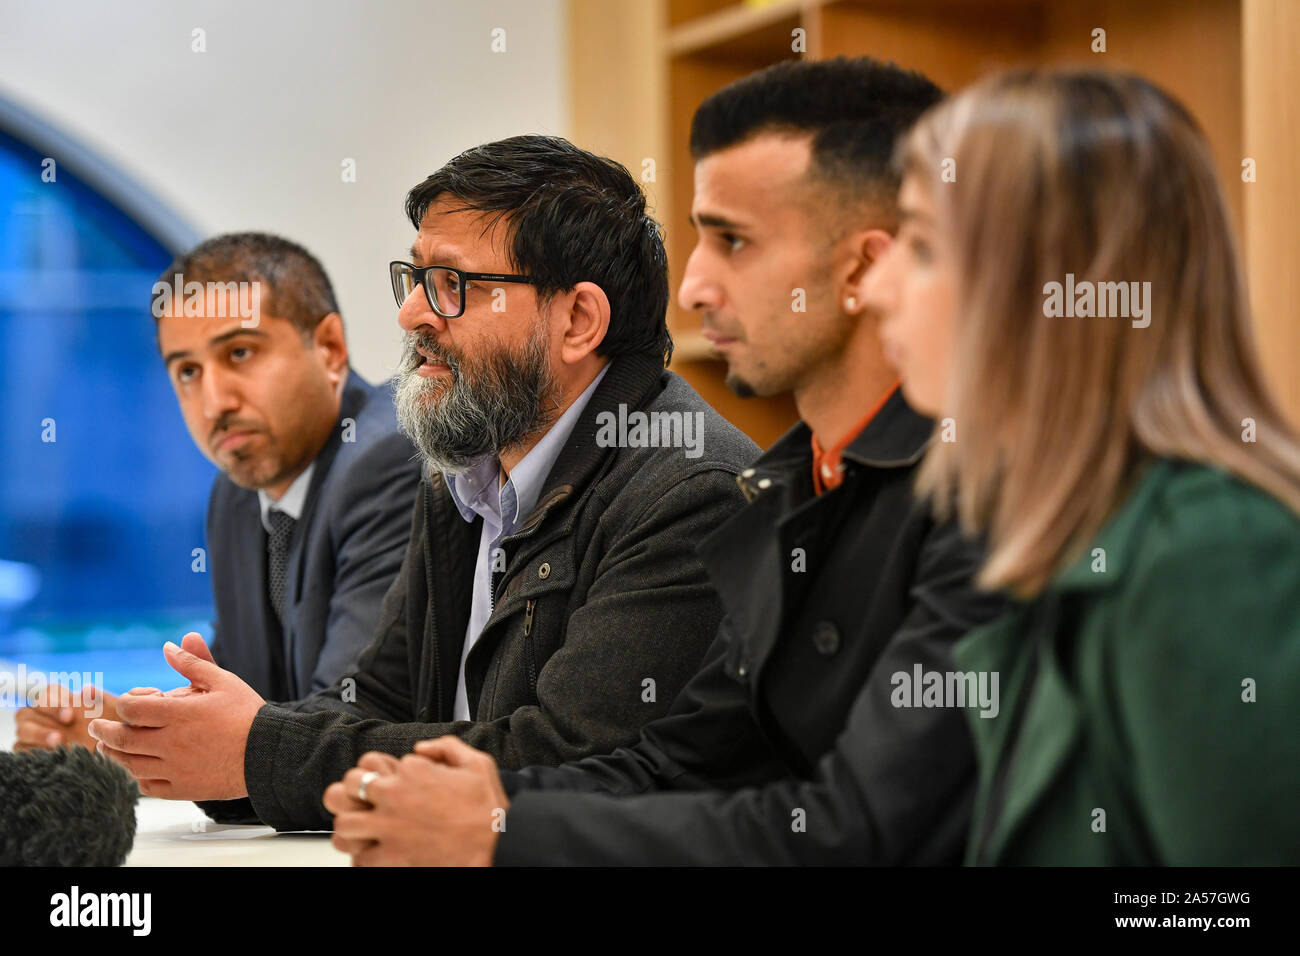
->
[[406, 135, 672, 362]]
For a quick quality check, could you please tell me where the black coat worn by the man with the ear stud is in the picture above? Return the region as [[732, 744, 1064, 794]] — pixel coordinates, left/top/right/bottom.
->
[[495, 393, 1004, 865]]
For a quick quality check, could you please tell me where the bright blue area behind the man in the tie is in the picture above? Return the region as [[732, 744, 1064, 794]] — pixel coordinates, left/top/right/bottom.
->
[[0, 119, 215, 691]]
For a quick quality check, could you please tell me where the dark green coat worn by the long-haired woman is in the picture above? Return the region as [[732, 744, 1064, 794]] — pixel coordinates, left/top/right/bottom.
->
[[954, 459, 1300, 865]]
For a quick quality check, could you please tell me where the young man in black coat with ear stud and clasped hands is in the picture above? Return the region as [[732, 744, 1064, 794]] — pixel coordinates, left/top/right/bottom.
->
[[325, 59, 1004, 865]]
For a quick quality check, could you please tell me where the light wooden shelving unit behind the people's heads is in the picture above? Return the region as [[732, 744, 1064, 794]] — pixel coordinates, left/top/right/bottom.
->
[[569, 0, 1300, 447]]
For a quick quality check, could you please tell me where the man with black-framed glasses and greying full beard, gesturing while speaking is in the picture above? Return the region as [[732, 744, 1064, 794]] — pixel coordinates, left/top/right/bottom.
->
[[91, 137, 758, 830]]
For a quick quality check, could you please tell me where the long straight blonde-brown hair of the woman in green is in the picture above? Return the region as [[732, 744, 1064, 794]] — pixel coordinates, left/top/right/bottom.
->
[[900, 70, 1300, 597]]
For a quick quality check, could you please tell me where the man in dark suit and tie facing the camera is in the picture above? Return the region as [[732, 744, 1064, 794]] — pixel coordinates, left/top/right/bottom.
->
[[18, 233, 420, 747]]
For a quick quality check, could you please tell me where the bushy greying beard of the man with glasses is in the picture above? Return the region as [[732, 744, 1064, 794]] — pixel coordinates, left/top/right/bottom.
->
[[393, 326, 560, 475]]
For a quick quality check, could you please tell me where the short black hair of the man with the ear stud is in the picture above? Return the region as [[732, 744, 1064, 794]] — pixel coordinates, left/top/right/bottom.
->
[[690, 56, 944, 218]]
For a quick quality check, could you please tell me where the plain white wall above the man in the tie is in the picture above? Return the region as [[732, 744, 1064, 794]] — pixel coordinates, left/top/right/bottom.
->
[[0, 0, 569, 381]]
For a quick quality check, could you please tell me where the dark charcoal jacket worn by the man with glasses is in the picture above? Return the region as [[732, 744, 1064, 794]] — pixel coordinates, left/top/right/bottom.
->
[[219, 356, 758, 830]]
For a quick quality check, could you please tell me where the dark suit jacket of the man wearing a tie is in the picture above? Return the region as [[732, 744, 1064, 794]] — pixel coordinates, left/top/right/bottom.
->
[[208, 369, 420, 700]]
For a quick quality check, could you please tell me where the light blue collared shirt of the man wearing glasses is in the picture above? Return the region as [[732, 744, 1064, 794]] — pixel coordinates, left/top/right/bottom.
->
[[443, 362, 610, 721]]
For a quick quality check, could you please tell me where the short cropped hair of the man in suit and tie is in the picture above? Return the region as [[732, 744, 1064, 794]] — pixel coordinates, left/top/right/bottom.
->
[[159, 233, 338, 336]]
